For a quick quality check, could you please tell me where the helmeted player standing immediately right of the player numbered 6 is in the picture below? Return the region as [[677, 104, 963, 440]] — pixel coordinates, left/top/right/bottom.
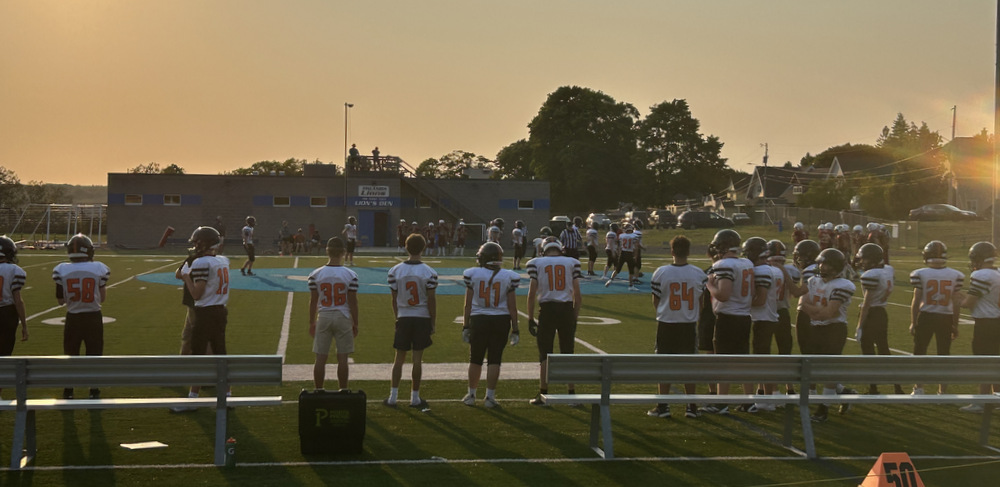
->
[[743, 237, 785, 413]]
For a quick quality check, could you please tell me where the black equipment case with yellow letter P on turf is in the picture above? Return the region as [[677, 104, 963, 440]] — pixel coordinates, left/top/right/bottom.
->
[[299, 390, 368, 454]]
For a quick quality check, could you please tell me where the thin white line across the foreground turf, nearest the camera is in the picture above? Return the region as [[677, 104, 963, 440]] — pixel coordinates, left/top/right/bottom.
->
[[7, 455, 1000, 472]]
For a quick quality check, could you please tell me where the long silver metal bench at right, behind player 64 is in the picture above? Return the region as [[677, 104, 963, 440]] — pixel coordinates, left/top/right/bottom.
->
[[544, 354, 1000, 459]]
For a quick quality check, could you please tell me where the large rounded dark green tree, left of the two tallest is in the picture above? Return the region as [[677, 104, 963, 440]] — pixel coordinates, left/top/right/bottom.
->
[[528, 86, 639, 213]]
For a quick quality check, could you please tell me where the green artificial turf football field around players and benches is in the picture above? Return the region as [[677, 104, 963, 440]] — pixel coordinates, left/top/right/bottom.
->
[[0, 223, 1000, 486]]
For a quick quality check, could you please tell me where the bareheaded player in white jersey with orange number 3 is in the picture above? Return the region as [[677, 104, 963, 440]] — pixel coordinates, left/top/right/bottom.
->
[[383, 233, 438, 409]]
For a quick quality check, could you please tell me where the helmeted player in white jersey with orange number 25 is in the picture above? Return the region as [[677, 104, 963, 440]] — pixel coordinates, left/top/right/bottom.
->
[[908, 240, 965, 395]]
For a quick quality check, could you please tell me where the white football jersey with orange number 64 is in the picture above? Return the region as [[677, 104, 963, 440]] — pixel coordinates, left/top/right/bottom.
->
[[649, 264, 708, 323]]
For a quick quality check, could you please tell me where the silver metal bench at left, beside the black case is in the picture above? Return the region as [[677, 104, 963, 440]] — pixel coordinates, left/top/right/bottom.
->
[[0, 355, 281, 469]]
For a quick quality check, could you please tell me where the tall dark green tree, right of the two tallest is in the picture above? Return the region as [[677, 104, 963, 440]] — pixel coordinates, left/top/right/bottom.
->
[[635, 100, 731, 206]]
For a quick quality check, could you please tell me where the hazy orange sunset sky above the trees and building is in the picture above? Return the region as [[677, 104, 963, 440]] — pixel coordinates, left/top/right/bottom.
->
[[0, 0, 996, 184]]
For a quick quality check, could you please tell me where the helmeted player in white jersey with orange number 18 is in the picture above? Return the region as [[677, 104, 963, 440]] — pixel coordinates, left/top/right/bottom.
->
[[527, 237, 582, 406]]
